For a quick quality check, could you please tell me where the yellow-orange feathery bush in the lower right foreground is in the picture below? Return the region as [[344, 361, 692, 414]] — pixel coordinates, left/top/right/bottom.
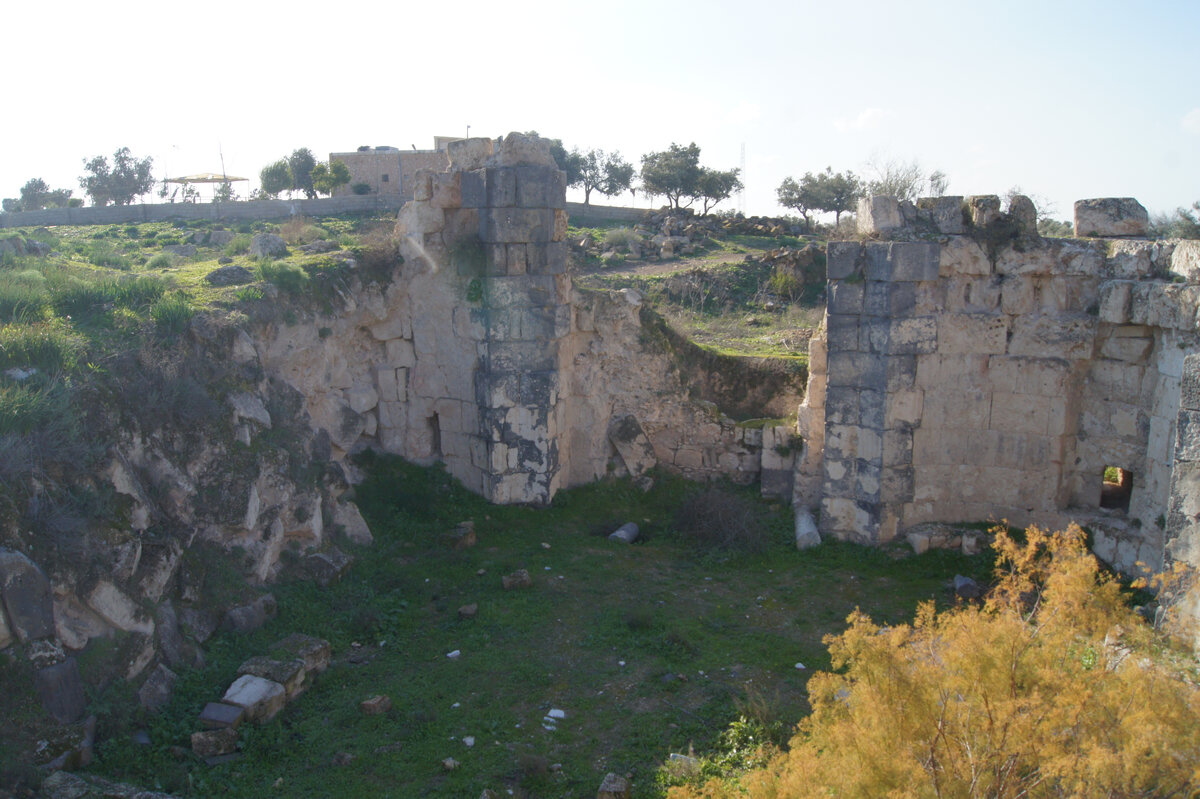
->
[[670, 525, 1200, 799]]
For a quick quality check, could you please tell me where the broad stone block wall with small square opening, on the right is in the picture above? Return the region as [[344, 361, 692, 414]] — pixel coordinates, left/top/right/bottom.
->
[[797, 197, 1200, 572]]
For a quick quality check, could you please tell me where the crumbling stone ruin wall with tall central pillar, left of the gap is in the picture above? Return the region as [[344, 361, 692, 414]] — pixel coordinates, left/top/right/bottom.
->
[[254, 134, 802, 504]]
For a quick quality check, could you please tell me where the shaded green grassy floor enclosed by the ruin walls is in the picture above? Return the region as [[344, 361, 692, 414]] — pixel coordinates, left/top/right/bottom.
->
[[82, 458, 989, 798]]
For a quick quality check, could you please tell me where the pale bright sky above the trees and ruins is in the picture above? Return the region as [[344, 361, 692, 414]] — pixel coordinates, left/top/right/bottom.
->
[[0, 0, 1200, 220]]
